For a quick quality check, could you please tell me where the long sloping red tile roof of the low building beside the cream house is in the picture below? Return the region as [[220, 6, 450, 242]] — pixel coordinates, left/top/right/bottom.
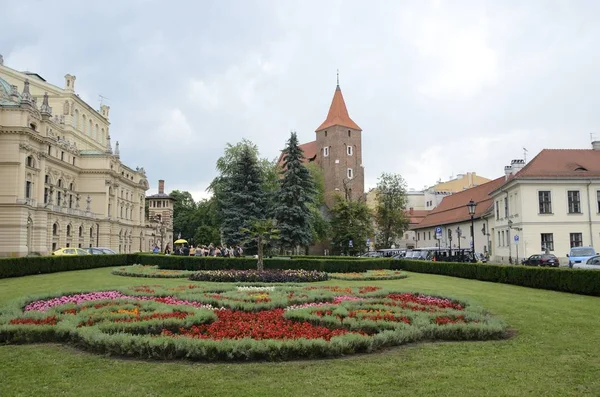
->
[[413, 177, 505, 229]]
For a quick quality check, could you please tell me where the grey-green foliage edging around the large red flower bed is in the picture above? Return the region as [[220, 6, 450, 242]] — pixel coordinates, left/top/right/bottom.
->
[[0, 289, 508, 361]]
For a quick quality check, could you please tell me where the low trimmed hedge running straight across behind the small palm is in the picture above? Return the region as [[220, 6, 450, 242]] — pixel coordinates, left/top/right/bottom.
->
[[136, 254, 392, 273]]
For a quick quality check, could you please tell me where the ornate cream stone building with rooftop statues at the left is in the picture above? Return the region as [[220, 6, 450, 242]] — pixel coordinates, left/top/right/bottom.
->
[[0, 58, 152, 256]]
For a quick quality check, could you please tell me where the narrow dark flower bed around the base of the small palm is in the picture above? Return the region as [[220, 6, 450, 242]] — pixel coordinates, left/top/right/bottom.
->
[[189, 270, 328, 283]]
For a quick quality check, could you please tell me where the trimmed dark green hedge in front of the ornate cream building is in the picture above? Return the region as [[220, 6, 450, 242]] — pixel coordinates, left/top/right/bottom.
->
[[0, 254, 136, 278]]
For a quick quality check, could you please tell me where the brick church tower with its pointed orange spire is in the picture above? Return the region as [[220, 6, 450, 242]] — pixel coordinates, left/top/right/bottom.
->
[[315, 77, 365, 207]]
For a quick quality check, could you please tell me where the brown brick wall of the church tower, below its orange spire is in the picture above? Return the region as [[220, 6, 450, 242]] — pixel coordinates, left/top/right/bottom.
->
[[316, 126, 365, 207]]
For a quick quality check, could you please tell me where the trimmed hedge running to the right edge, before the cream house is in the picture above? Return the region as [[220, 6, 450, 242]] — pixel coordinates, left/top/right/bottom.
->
[[391, 259, 600, 296]]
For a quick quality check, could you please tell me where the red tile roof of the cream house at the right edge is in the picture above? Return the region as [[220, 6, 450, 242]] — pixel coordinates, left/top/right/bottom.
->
[[514, 149, 600, 179]]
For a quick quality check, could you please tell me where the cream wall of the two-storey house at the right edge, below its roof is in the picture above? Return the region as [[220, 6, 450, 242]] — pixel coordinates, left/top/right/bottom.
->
[[493, 180, 600, 264]]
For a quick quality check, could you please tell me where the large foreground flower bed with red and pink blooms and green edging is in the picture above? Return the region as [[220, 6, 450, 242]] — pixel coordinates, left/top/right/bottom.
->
[[0, 284, 506, 361]]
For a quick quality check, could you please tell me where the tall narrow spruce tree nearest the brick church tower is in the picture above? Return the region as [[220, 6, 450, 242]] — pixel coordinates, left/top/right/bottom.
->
[[274, 132, 315, 249]]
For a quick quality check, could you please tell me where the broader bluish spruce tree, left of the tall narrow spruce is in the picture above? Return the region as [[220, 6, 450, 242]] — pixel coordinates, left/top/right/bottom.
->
[[219, 146, 267, 245]]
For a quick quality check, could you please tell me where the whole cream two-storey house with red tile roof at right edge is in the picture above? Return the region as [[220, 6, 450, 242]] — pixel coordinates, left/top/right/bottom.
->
[[491, 148, 600, 264]]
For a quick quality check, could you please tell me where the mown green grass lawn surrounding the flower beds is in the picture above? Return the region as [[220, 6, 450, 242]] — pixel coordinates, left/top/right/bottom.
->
[[0, 268, 600, 397]]
